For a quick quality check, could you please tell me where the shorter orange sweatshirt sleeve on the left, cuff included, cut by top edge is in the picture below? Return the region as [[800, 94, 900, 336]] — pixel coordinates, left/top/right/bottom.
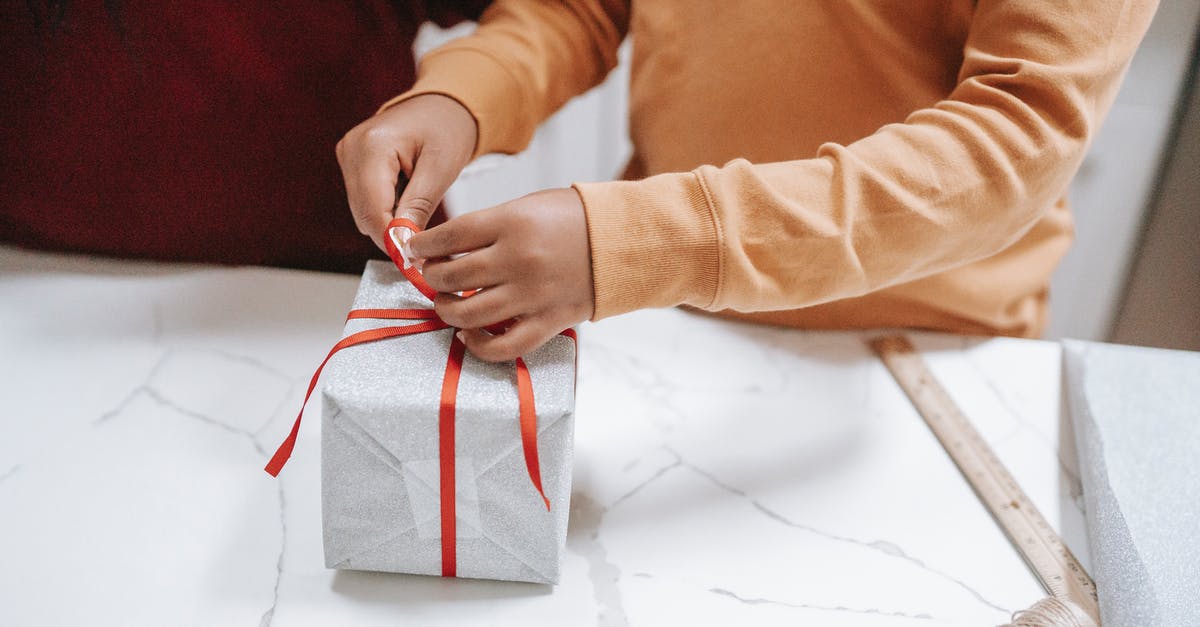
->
[[379, 0, 629, 156]]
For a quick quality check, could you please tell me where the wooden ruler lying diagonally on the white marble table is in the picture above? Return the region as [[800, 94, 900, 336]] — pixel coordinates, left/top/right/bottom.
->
[[868, 335, 1099, 622]]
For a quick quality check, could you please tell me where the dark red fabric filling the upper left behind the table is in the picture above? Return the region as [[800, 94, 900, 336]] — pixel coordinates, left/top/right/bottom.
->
[[0, 0, 484, 271]]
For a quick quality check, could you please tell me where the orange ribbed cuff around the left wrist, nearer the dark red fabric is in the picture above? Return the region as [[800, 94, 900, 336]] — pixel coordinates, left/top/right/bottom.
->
[[379, 48, 536, 159]]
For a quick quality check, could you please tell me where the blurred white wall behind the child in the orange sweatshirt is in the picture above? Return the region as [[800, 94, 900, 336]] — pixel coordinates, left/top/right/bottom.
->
[[416, 0, 1200, 340]]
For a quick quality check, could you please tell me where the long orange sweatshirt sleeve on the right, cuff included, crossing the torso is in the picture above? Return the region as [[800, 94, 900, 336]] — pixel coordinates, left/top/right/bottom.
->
[[576, 0, 1157, 320]]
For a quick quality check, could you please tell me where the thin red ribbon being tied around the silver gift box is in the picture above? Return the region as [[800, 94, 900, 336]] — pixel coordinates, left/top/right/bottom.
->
[[264, 217, 577, 577]]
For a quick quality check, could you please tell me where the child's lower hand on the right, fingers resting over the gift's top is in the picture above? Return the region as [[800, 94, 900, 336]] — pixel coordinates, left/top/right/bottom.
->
[[409, 189, 595, 362]]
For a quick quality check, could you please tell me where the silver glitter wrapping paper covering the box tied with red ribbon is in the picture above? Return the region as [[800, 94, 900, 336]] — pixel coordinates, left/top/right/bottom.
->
[[322, 262, 575, 584]]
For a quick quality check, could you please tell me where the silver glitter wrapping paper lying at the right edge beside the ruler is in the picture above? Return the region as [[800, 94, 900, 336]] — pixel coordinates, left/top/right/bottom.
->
[[1063, 340, 1200, 627]]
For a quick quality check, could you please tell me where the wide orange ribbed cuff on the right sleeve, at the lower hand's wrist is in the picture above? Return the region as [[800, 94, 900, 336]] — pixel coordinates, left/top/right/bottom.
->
[[575, 173, 721, 320]]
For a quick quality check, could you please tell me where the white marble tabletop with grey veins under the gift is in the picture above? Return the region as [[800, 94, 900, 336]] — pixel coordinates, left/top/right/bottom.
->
[[0, 247, 1087, 627]]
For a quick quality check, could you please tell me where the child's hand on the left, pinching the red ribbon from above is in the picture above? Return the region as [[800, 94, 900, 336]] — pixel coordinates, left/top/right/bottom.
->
[[337, 94, 479, 249]]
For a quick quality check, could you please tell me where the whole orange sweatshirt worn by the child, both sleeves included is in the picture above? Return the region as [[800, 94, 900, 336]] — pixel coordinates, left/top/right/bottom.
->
[[385, 0, 1157, 336]]
